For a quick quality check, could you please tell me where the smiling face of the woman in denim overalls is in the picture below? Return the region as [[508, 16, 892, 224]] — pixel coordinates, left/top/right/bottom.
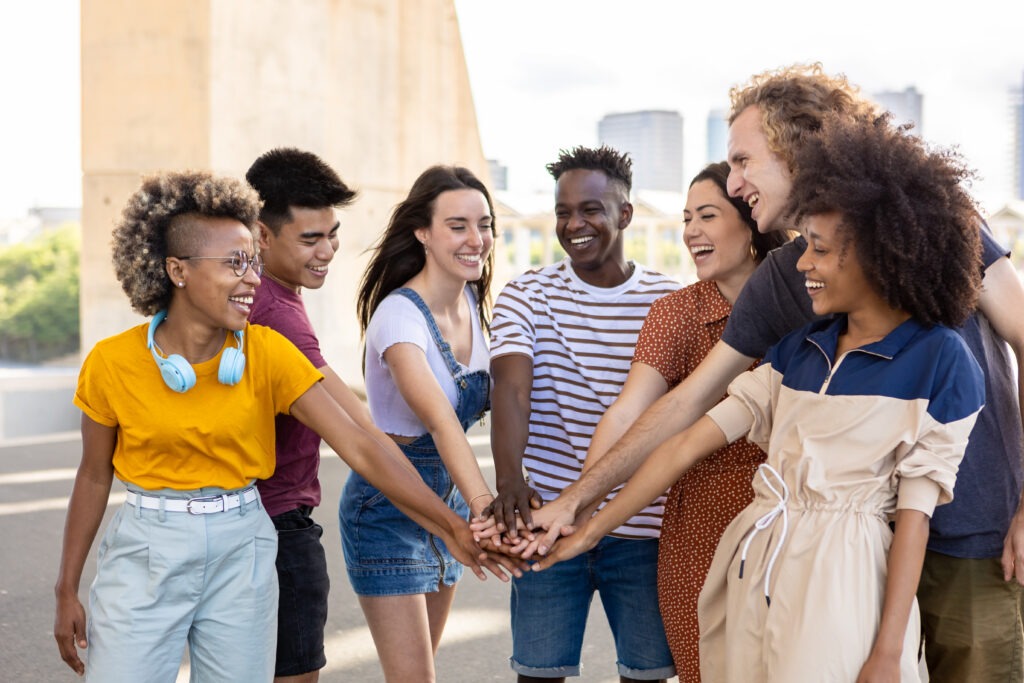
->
[[416, 189, 495, 283]]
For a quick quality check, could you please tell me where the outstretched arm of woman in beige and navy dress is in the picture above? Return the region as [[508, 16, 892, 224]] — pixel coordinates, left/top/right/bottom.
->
[[523, 417, 728, 571]]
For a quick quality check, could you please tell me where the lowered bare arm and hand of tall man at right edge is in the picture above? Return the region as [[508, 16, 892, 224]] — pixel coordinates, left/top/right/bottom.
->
[[978, 258, 1024, 585]]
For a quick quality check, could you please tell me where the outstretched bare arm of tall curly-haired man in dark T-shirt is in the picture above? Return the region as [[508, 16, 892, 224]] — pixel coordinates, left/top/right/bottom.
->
[[534, 341, 754, 548]]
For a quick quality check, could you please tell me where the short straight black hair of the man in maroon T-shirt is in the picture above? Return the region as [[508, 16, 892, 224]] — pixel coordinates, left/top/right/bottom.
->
[[246, 147, 356, 234]]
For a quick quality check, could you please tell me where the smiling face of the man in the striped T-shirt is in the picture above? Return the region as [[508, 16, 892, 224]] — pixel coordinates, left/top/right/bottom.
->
[[555, 169, 633, 286]]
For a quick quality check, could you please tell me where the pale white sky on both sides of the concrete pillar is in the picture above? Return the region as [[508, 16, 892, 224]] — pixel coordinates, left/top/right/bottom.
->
[[0, 0, 1024, 219]]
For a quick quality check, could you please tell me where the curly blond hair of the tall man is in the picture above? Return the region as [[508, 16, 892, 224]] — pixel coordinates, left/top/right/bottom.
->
[[729, 62, 879, 172]]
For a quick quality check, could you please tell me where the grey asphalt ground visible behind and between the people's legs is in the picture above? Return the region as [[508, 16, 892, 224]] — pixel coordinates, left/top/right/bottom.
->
[[0, 429, 671, 683]]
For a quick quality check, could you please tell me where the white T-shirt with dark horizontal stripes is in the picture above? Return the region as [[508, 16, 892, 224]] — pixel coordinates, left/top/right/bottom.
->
[[490, 260, 680, 539]]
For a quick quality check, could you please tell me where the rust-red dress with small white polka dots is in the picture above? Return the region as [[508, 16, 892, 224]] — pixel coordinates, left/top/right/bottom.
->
[[633, 282, 765, 683]]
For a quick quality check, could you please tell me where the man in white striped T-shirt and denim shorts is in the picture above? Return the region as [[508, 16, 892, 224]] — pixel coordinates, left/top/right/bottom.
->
[[490, 146, 679, 683]]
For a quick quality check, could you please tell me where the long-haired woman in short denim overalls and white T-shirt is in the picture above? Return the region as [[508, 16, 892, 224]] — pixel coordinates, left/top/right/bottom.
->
[[339, 166, 494, 681]]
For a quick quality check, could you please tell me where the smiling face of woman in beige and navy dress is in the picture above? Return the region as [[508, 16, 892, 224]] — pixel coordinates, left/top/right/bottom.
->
[[797, 212, 882, 315]]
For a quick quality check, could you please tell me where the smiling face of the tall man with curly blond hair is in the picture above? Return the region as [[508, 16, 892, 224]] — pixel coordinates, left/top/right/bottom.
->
[[728, 106, 793, 232]]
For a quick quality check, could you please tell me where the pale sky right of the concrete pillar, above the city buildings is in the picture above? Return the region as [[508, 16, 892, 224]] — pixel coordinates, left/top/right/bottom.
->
[[456, 0, 1024, 211]]
